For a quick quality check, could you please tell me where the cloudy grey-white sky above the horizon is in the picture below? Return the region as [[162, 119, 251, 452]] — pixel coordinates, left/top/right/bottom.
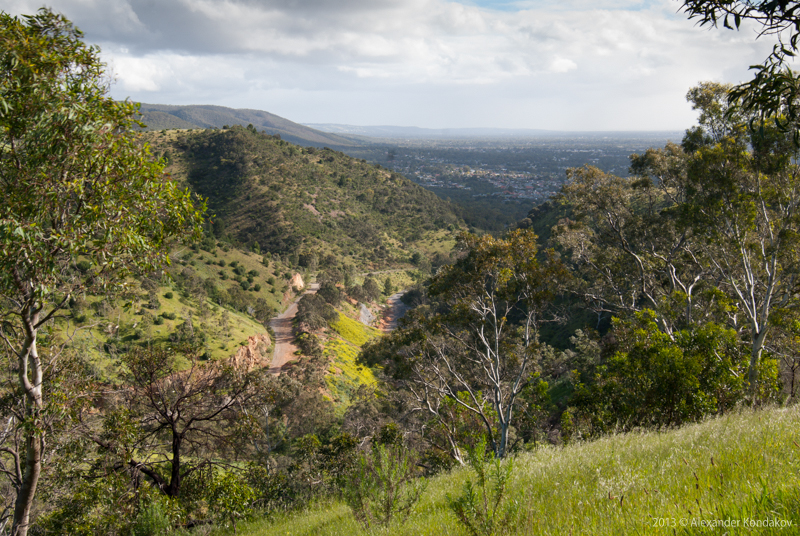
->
[[0, 0, 788, 131]]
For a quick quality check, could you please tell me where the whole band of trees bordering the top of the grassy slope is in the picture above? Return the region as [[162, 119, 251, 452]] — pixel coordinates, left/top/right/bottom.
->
[[361, 83, 800, 474]]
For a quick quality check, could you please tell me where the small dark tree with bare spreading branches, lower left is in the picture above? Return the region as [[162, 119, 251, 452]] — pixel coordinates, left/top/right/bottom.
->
[[92, 348, 261, 497]]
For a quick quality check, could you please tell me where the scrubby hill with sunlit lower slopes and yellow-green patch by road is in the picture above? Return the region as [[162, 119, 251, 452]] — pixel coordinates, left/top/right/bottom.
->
[[67, 126, 462, 382]]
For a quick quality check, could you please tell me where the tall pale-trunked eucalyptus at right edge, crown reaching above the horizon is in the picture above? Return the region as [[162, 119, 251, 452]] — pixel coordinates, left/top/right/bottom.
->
[[555, 83, 800, 393]]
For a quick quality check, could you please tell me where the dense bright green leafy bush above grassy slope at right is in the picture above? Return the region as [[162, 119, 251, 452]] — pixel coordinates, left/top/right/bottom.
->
[[562, 310, 747, 432]]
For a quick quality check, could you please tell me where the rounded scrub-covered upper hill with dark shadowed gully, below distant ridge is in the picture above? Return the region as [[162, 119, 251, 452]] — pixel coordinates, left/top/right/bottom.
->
[[148, 126, 463, 269]]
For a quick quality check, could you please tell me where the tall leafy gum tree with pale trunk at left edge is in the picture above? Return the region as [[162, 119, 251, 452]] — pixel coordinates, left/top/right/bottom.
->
[[0, 9, 202, 536]]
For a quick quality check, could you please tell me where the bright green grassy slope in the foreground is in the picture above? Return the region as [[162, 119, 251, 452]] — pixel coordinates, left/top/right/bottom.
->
[[223, 407, 800, 536]]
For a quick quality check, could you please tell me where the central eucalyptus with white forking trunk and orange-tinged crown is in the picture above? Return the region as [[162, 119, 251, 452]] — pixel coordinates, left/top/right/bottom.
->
[[406, 230, 567, 459]]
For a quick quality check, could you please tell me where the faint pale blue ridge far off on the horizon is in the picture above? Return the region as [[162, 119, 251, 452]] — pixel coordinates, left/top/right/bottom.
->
[[306, 123, 560, 139]]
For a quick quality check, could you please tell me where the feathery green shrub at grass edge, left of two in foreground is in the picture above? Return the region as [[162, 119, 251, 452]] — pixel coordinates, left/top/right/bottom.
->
[[342, 444, 426, 529]]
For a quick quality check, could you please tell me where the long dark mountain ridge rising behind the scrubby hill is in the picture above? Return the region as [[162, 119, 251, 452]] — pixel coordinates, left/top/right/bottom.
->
[[139, 103, 357, 148]]
